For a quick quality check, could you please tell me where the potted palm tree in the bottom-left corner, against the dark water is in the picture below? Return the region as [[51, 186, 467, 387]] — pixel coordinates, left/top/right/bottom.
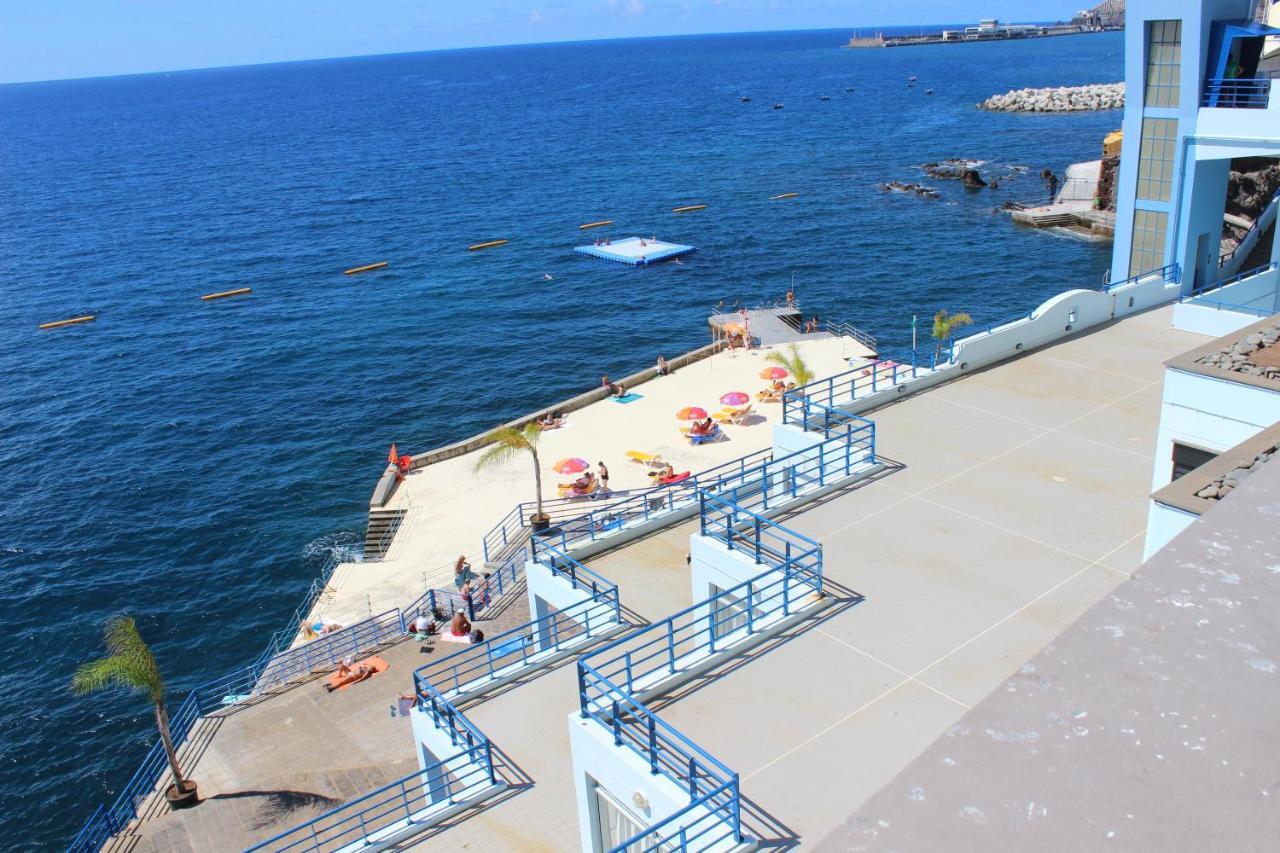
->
[[72, 616, 200, 808]]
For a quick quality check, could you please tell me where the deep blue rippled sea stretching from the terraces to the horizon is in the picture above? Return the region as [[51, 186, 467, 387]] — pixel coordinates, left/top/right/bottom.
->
[[0, 31, 1123, 848]]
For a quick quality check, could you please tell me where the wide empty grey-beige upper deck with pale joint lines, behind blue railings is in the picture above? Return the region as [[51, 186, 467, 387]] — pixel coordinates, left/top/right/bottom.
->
[[409, 307, 1203, 850]]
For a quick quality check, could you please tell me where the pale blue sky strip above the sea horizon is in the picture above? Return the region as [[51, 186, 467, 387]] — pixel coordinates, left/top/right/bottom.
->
[[0, 0, 1093, 83]]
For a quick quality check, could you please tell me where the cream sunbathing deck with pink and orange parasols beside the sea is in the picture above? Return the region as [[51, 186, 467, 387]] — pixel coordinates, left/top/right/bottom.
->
[[325, 337, 870, 621]]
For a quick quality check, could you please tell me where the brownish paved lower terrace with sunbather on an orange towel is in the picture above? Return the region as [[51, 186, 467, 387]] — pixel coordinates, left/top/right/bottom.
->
[[120, 583, 529, 853]]
